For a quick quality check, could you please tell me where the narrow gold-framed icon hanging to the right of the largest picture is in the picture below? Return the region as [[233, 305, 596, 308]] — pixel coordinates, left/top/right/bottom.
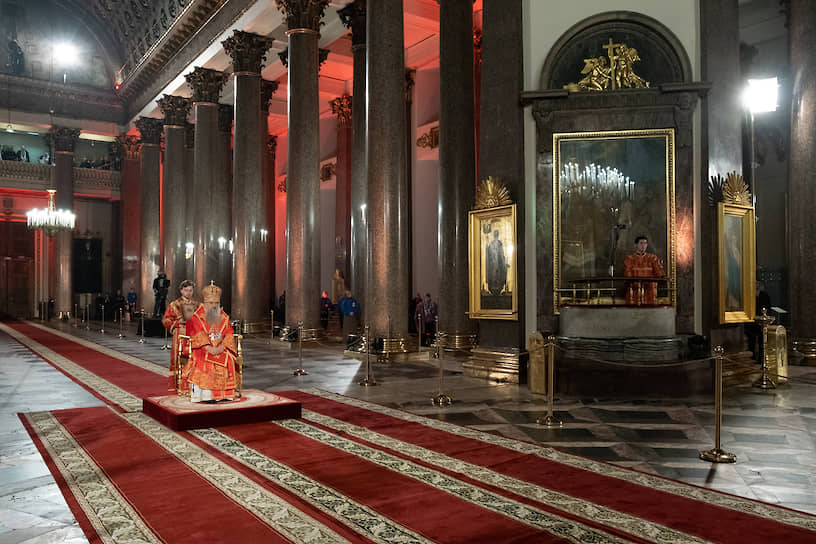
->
[[717, 202, 756, 324]]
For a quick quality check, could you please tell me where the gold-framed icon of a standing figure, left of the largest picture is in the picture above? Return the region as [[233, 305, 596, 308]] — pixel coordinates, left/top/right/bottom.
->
[[468, 204, 518, 320]]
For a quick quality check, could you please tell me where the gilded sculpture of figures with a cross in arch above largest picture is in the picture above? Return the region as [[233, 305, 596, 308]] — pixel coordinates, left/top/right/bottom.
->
[[564, 38, 649, 92]]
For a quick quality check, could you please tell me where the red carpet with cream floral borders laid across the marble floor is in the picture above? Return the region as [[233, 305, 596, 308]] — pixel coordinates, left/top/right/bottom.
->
[[3, 324, 816, 544]]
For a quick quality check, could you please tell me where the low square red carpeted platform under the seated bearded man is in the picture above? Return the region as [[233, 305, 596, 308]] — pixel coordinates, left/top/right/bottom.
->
[[142, 389, 301, 431]]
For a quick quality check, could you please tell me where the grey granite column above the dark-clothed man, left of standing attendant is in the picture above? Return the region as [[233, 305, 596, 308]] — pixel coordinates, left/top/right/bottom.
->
[[136, 117, 162, 317]]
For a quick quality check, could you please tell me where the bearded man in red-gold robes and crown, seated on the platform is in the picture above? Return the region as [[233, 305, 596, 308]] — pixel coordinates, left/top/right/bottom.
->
[[184, 282, 237, 403]]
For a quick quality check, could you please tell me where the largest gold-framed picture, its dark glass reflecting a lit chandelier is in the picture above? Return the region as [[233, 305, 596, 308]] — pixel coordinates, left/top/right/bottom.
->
[[553, 128, 677, 314]]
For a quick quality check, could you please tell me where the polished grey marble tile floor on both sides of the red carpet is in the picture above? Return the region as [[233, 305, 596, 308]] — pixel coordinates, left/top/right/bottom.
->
[[0, 316, 816, 544]]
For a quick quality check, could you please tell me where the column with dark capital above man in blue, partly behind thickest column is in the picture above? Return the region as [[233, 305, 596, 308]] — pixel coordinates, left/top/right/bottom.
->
[[337, 0, 368, 310]]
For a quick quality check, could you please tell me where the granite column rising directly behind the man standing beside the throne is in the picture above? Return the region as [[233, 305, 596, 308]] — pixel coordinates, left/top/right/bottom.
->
[[157, 95, 192, 294]]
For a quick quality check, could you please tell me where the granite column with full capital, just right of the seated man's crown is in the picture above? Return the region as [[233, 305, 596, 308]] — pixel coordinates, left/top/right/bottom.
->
[[222, 30, 272, 332]]
